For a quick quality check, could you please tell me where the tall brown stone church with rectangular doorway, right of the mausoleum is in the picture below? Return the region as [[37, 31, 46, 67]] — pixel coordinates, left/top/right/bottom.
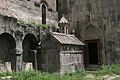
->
[[58, 0, 120, 65]]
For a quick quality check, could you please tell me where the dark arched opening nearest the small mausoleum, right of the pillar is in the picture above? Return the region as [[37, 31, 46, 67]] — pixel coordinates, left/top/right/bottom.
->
[[22, 34, 37, 68]]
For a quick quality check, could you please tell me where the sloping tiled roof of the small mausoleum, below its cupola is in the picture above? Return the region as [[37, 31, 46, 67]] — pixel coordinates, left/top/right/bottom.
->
[[50, 32, 84, 45]]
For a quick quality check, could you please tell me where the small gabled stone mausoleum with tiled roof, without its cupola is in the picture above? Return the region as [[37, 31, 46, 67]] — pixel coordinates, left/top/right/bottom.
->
[[41, 32, 84, 74]]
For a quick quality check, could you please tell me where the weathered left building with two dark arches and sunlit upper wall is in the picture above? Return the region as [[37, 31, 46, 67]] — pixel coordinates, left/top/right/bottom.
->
[[0, 0, 58, 71]]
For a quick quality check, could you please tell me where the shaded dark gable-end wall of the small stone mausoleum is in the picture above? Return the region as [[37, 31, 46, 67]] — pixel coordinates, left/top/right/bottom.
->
[[40, 35, 60, 73]]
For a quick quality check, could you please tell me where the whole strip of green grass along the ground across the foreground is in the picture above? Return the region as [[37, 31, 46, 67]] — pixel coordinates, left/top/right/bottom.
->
[[0, 64, 120, 80]]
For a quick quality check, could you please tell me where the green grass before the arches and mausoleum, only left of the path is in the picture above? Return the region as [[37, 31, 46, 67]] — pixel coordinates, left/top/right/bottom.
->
[[0, 70, 86, 80]]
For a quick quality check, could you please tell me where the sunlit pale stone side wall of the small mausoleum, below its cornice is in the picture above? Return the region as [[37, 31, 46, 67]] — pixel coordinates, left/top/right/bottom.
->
[[60, 53, 84, 74]]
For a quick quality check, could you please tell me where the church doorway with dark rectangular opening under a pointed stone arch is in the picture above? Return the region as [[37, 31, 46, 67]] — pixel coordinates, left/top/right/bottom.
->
[[84, 24, 102, 70]]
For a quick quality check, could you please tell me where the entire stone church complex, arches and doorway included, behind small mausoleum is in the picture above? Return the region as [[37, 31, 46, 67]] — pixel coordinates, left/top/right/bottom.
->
[[0, 0, 120, 70]]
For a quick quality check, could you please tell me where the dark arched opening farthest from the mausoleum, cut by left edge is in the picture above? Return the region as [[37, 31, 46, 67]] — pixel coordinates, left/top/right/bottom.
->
[[0, 33, 16, 70]]
